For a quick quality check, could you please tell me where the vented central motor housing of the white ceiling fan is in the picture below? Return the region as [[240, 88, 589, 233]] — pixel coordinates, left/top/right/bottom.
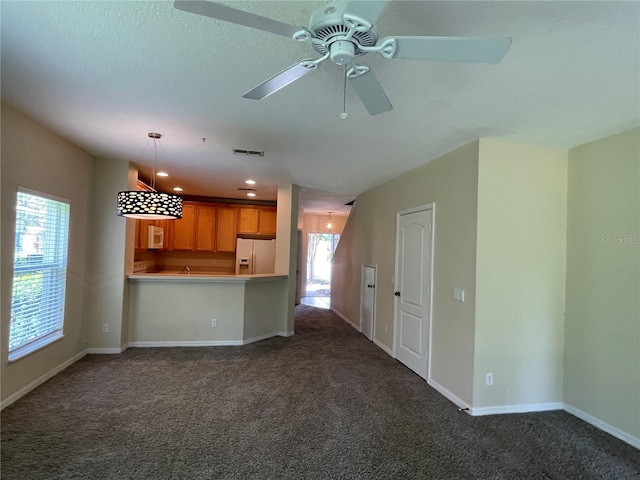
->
[[309, 1, 378, 65]]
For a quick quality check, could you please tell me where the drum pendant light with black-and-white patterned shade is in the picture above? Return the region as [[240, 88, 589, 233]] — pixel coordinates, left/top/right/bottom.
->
[[116, 132, 182, 220]]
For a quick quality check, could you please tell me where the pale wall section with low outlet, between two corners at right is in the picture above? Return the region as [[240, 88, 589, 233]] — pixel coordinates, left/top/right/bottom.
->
[[473, 139, 567, 413]]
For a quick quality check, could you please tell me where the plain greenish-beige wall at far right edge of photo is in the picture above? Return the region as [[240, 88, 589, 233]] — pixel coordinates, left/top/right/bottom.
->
[[564, 129, 640, 446]]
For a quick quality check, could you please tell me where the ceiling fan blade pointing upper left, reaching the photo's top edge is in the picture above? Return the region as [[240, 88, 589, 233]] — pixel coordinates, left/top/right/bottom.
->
[[173, 0, 301, 38]]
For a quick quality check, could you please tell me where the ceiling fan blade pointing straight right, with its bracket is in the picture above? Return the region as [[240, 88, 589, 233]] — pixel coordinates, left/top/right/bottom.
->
[[379, 37, 511, 63]]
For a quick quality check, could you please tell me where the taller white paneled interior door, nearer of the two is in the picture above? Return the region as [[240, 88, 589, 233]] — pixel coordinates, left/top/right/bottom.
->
[[394, 206, 433, 379]]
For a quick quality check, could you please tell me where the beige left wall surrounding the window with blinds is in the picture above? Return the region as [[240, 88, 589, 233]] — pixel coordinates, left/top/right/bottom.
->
[[0, 104, 94, 406]]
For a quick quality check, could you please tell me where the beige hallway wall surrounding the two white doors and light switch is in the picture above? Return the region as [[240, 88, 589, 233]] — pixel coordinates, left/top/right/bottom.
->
[[331, 142, 478, 403]]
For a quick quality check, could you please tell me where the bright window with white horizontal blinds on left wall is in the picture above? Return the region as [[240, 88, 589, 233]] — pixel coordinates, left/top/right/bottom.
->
[[9, 188, 69, 360]]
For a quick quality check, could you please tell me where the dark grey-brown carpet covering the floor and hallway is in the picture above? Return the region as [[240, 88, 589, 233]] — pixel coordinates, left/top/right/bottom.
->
[[0, 305, 640, 480]]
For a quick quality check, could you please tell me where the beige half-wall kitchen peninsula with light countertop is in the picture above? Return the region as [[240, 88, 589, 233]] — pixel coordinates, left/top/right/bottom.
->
[[127, 272, 293, 347]]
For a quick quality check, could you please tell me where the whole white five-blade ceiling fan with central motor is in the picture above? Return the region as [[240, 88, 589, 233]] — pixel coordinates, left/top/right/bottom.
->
[[174, 0, 511, 115]]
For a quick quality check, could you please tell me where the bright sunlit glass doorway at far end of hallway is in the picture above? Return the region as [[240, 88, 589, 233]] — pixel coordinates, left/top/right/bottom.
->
[[302, 233, 340, 308]]
